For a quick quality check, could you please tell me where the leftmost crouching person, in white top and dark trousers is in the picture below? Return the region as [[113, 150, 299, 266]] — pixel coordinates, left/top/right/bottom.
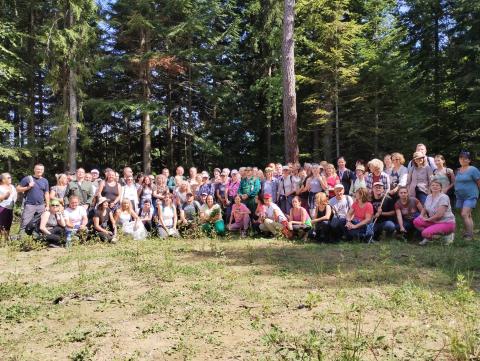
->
[[38, 199, 67, 245]]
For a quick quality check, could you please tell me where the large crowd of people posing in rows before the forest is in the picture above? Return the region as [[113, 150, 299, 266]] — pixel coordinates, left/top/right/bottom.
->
[[0, 144, 480, 246]]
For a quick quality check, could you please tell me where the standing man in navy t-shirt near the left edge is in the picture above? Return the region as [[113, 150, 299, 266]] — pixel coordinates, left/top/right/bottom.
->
[[17, 163, 50, 236]]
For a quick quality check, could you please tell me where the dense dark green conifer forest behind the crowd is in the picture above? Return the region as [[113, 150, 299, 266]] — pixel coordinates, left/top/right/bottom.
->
[[0, 0, 480, 175]]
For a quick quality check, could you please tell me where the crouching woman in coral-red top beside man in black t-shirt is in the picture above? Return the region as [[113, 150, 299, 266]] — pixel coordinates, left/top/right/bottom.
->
[[345, 188, 373, 241]]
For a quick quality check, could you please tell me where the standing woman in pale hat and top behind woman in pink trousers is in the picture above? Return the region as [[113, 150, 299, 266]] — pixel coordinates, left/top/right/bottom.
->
[[407, 152, 433, 204]]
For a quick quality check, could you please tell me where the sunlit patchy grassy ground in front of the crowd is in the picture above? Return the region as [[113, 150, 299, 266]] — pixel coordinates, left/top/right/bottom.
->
[[0, 212, 480, 361]]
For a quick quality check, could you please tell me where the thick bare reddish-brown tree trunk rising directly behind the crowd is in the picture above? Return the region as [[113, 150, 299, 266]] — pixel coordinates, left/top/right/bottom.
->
[[282, 0, 299, 163]]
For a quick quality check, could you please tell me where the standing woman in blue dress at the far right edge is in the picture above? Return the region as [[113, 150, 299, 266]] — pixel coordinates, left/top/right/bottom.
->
[[455, 151, 480, 241]]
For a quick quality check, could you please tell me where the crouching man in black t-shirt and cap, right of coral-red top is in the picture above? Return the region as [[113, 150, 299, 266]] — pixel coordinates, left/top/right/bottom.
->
[[371, 182, 395, 241]]
